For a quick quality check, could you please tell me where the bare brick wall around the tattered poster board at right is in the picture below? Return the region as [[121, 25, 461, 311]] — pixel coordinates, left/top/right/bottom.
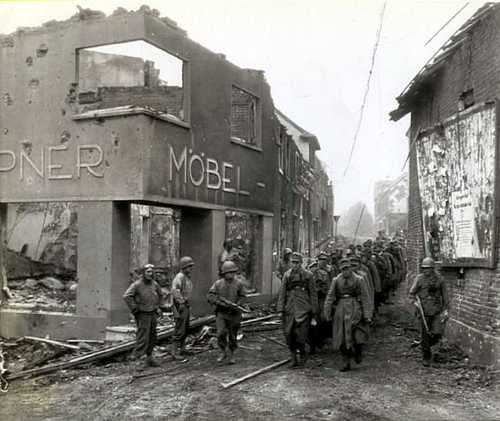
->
[[408, 9, 500, 366]]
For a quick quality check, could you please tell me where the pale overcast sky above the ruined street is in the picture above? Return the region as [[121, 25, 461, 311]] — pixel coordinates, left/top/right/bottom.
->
[[0, 0, 484, 213]]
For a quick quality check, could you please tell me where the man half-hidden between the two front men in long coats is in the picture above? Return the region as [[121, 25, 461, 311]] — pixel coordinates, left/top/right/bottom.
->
[[309, 252, 331, 354]]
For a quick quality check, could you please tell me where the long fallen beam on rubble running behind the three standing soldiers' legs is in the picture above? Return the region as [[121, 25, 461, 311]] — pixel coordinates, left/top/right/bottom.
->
[[8, 316, 215, 380]]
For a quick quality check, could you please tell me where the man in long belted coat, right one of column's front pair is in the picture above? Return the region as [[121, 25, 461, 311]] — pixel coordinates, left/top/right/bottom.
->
[[323, 259, 372, 371]]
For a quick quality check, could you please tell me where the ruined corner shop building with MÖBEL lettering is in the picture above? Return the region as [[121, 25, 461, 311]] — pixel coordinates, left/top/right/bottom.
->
[[0, 7, 333, 339]]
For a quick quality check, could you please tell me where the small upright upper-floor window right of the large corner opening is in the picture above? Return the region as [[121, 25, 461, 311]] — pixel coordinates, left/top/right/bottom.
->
[[231, 86, 260, 146]]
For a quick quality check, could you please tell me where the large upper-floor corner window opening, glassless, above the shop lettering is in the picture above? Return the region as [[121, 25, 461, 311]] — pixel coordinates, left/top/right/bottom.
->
[[78, 41, 187, 120]]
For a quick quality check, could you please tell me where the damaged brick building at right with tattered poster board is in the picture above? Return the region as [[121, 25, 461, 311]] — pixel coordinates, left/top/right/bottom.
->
[[391, 3, 500, 365]]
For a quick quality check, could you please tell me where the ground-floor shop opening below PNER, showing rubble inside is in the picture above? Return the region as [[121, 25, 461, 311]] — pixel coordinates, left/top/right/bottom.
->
[[6, 202, 78, 313]]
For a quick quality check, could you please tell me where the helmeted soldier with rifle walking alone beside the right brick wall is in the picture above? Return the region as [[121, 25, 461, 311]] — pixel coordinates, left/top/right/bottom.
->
[[410, 257, 448, 367]]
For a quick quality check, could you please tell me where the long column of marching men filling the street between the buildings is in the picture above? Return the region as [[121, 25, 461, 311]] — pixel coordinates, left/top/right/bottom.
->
[[277, 239, 406, 371]]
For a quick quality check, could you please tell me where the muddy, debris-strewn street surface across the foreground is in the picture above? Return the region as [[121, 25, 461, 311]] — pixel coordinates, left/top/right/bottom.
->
[[0, 292, 500, 421]]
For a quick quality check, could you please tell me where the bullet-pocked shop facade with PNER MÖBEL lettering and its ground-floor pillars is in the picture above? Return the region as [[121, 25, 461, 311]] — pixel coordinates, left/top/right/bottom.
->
[[0, 8, 277, 336]]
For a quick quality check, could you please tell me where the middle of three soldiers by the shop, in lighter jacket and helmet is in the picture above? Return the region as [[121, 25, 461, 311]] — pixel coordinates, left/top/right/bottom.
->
[[171, 256, 194, 359]]
